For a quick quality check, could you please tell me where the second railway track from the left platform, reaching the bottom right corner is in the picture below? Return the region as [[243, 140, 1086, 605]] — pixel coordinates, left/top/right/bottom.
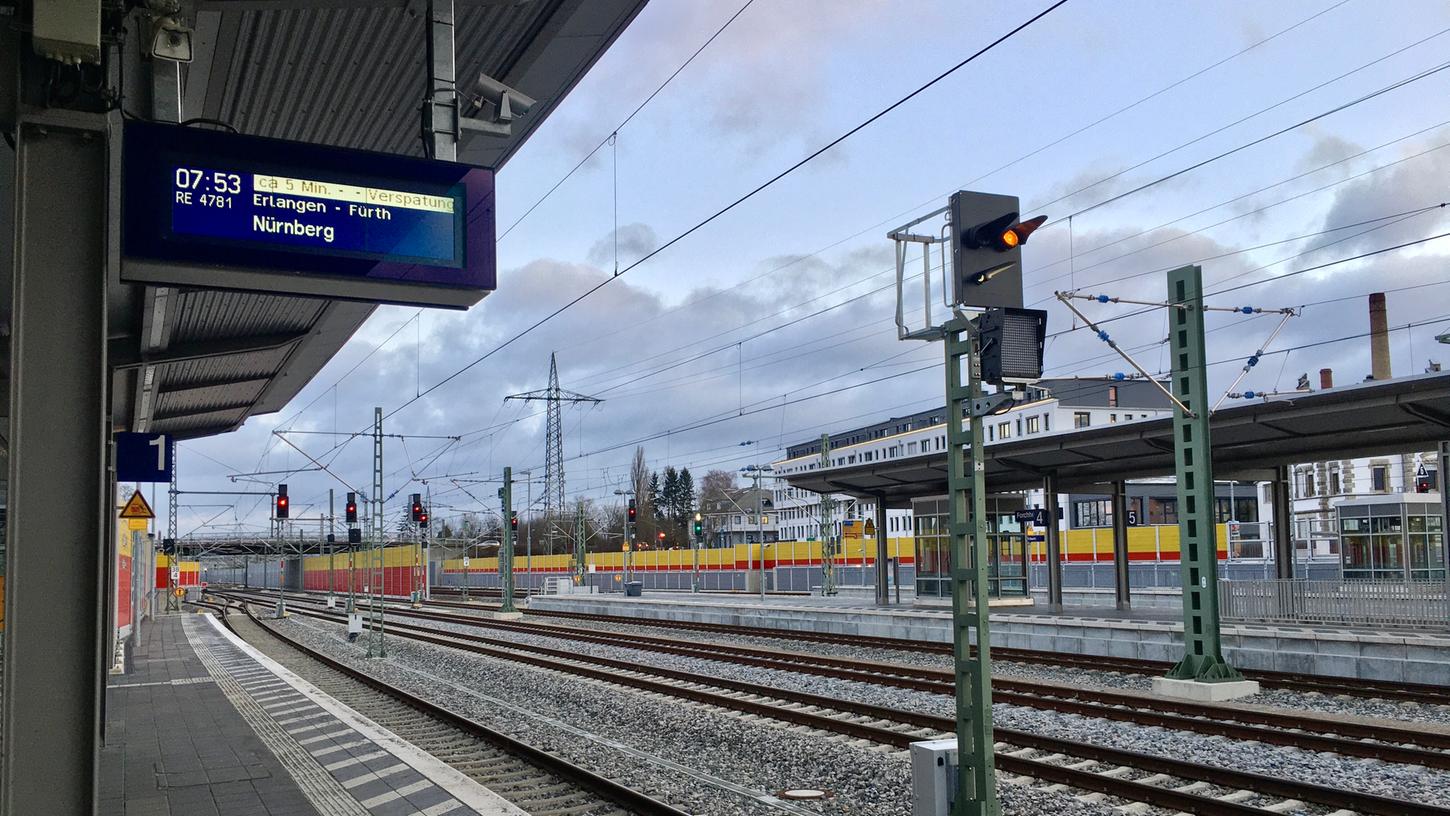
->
[[234, 594, 1450, 816]]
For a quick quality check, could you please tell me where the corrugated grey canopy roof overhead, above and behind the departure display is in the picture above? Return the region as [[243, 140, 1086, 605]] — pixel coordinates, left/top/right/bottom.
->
[[110, 0, 645, 439]]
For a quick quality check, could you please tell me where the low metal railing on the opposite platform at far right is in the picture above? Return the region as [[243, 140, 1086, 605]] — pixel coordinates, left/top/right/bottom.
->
[[1218, 578, 1450, 629]]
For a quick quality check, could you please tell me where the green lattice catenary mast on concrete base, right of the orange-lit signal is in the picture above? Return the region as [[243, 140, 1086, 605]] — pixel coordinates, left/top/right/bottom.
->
[[1167, 267, 1243, 683]]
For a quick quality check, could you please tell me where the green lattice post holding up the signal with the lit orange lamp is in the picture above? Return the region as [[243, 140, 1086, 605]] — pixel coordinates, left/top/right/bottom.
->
[[943, 317, 1002, 816]]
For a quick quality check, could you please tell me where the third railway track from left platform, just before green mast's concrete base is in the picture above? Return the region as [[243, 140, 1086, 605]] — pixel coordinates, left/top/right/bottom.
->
[[211, 588, 1450, 770]]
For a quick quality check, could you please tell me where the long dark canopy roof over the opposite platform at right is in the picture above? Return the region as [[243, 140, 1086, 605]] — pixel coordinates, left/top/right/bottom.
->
[[783, 372, 1450, 507]]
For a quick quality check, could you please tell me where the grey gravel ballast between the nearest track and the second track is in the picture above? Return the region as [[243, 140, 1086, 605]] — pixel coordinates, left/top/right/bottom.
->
[[263, 617, 1114, 816]]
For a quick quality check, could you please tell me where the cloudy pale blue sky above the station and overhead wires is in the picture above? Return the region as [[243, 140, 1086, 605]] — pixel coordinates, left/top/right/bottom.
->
[[175, 0, 1450, 535]]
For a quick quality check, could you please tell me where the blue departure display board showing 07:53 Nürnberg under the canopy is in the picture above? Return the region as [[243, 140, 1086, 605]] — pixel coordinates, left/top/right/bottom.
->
[[122, 122, 496, 307]]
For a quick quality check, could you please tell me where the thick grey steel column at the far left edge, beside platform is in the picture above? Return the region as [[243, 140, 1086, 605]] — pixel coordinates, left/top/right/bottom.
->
[[0, 112, 110, 816]]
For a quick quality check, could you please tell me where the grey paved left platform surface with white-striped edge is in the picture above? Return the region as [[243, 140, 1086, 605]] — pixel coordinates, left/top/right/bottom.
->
[[100, 615, 521, 816]]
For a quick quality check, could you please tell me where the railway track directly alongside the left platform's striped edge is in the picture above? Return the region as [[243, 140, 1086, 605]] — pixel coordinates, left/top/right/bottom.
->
[[190, 601, 687, 816]]
